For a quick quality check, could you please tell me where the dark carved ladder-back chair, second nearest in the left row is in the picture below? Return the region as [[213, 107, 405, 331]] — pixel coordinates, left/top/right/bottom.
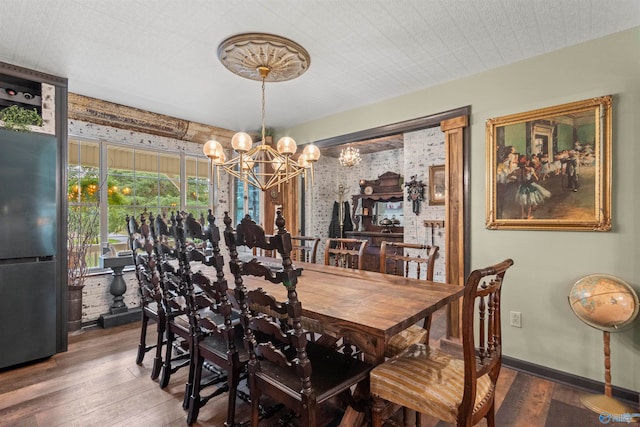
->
[[187, 211, 249, 426]]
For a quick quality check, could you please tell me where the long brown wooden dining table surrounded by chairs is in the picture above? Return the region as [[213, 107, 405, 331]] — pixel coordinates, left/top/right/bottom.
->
[[218, 258, 464, 426]]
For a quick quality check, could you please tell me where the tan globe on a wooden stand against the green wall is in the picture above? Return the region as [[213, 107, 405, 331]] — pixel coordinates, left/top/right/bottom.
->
[[569, 274, 640, 421]]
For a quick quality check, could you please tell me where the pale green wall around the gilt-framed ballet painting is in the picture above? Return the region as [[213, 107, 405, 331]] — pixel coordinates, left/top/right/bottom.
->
[[287, 27, 640, 391]]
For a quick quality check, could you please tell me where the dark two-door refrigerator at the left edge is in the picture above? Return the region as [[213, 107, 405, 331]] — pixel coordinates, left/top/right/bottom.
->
[[0, 130, 59, 368]]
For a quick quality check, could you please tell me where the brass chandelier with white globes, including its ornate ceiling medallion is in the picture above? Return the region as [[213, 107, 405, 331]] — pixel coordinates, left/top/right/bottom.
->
[[203, 33, 320, 191]]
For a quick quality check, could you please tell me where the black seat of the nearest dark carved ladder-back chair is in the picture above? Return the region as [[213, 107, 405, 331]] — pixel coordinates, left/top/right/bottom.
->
[[256, 342, 372, 403]]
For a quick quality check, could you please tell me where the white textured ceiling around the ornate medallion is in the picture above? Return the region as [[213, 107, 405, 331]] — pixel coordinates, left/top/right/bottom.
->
[[0, 0, 640, 131]]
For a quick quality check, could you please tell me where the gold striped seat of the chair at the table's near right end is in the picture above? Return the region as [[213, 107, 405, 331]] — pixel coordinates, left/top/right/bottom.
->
[[370, 344, 495, 424]]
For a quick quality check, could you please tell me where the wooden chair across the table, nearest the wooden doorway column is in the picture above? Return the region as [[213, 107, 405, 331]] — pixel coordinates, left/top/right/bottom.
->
[[380, 241, 439, 357]]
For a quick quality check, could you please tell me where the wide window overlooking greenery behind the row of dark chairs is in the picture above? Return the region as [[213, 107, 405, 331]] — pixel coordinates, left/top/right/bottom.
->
[[68, 137, 210, 267]]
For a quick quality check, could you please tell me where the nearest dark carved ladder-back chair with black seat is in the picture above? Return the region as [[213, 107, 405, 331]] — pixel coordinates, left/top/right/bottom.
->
[[237, 212, 371, 427]]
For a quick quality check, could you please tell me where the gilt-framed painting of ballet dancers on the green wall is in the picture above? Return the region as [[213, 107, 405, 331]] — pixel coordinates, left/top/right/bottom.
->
[[486, 96, 612, 231]]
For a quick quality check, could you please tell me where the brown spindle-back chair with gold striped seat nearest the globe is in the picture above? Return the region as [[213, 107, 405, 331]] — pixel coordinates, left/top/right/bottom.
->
[[370, 259, 513, 427]]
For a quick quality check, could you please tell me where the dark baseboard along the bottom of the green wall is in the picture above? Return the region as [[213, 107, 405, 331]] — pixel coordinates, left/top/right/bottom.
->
[[502, 355, 640, 407]]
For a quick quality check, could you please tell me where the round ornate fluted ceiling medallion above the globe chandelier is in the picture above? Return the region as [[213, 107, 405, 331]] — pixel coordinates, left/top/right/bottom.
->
[[218, 33, 311, 82]]
